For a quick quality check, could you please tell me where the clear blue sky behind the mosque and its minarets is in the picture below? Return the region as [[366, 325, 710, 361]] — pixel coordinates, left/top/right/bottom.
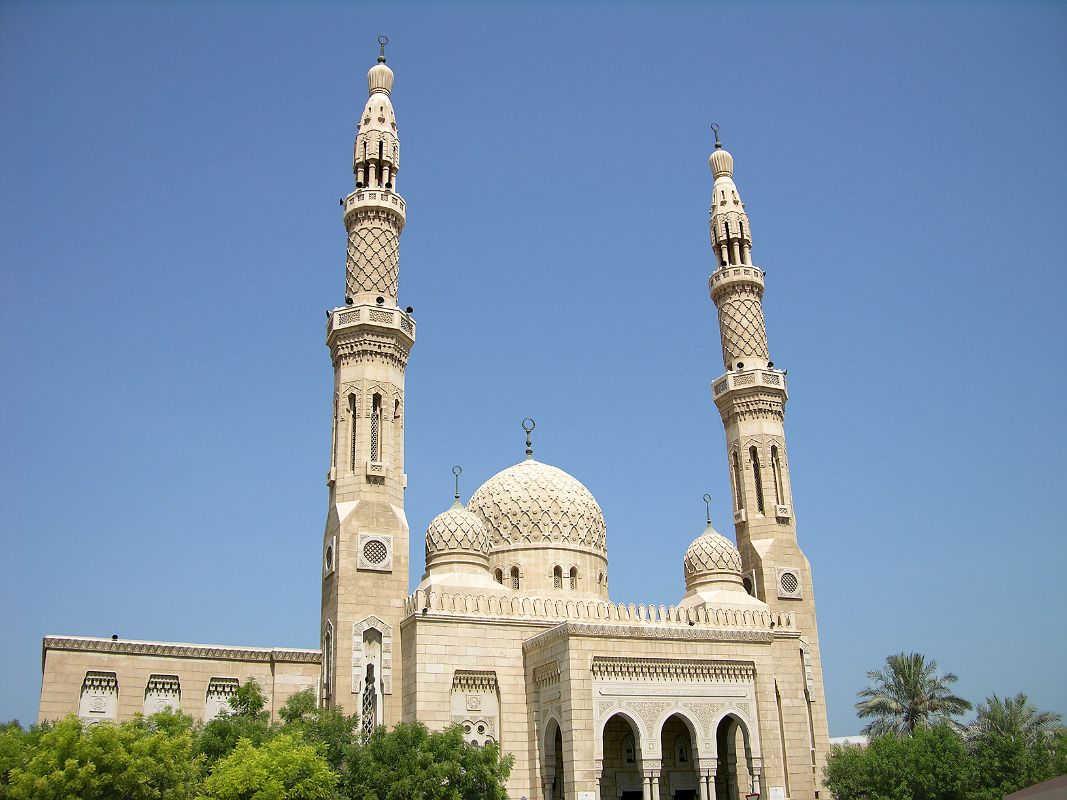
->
[[0, 2, 1067, 735]]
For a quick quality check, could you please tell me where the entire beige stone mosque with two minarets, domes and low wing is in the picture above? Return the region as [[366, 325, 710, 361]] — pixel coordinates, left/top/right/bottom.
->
[[39, 47, 829, 800]]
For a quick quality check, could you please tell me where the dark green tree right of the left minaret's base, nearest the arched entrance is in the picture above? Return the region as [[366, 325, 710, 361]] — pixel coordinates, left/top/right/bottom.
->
[[341, 722, 514, 800]]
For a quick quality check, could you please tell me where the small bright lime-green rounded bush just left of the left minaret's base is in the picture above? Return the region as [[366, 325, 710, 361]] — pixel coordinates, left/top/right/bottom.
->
[[202, 733, 337, 800]]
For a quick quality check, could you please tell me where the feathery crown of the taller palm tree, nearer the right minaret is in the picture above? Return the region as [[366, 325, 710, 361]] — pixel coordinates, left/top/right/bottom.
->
[[856, 653, 971, 736]]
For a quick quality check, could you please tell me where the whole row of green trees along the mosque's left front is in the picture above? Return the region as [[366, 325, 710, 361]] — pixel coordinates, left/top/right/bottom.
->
[[0, 681, 512, 800]]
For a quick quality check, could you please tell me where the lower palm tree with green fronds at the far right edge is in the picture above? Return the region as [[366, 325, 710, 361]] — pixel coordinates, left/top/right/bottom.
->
[[967, 692, 1063, 800]]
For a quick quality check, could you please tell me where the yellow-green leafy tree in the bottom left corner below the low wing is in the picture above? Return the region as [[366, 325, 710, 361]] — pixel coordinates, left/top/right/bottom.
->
[[4, 715, 203, 800]]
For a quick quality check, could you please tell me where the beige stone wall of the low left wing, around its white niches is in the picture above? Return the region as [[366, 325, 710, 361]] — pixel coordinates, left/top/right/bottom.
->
[[37, 637, 319, 721]]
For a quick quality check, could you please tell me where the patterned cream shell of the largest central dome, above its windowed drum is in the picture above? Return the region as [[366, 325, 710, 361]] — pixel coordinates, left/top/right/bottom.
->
[[467, 459, 607, 554]]
